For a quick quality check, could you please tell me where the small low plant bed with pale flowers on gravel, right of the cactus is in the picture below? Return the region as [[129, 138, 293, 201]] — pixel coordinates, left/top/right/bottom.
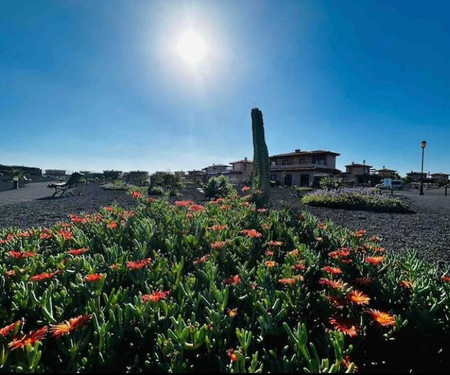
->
[[302, 188, 408, 212]]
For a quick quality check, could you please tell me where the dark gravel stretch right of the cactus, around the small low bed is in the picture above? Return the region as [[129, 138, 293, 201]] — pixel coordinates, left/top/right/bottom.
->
[[272, 188, 450, 266]]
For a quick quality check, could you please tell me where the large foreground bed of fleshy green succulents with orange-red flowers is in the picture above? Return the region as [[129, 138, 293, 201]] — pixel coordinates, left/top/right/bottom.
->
[[0, 192, 450, 372]]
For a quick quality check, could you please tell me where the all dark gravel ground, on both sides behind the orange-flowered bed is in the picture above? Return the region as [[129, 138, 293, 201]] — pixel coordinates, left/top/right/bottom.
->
[[0, 183, 450, 265]]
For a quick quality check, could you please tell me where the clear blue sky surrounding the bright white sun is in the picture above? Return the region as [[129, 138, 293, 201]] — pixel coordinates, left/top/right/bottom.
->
[[0, 0, 450, 175]]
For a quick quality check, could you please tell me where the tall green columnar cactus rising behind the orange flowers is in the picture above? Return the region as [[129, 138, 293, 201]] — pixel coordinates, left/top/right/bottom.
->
[[252, 108, 270, 207]]
